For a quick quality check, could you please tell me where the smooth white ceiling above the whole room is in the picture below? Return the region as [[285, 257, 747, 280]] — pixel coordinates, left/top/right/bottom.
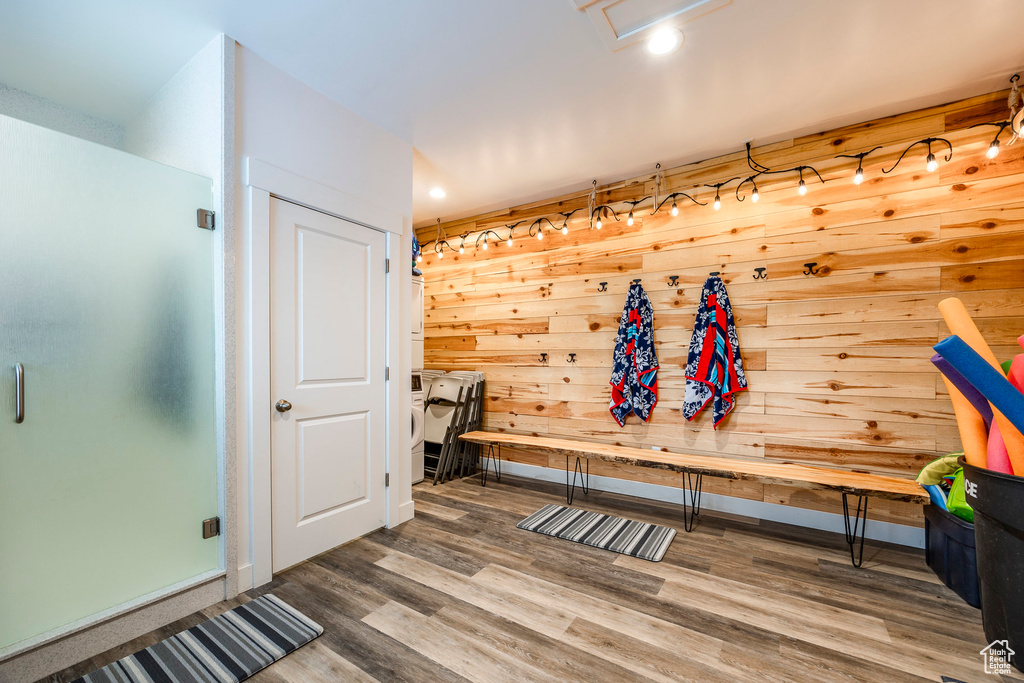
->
[[0, 0, 1024, 224]]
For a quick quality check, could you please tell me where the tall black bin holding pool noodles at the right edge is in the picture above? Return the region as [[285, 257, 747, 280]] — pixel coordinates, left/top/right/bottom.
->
[[959, 458, 1024, 671]]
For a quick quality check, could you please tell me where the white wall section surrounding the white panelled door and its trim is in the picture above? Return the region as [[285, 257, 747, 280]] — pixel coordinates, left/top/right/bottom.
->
[[234, 41, 413, 590]]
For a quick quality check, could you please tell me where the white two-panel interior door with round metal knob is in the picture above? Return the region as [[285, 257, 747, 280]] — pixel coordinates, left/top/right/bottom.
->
[[266, 199, 387, 571]]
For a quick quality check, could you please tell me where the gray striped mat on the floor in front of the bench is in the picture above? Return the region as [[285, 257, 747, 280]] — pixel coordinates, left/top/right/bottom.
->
[[516, 505, 676, 562]]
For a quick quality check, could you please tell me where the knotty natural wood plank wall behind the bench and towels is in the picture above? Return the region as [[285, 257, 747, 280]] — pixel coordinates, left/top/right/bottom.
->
[[420, 92, 1024, 525]]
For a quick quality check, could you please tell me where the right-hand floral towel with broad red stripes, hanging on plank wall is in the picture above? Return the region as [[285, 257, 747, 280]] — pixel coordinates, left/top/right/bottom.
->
[[683, 275, 746, 429]]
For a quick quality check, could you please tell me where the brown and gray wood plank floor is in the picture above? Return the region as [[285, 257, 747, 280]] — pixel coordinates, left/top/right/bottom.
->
[[48, 476, 1024, 683]]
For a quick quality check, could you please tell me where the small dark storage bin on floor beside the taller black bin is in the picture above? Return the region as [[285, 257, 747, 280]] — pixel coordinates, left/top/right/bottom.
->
[[925, 505, 981, 607]]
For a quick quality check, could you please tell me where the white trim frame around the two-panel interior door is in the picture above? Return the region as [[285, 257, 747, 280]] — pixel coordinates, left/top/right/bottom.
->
[[239, 157, 413, 591]]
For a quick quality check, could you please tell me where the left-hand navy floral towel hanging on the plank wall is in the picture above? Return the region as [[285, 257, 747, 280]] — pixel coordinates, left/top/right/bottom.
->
[[608, 283, 657, 427]]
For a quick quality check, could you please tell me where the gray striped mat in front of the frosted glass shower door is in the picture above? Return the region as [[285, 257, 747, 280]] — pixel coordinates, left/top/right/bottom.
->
[[74, 595, 324, 683]]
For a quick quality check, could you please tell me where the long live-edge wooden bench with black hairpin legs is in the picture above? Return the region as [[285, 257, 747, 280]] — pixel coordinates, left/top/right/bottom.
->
[[460, 431, 929, 567]]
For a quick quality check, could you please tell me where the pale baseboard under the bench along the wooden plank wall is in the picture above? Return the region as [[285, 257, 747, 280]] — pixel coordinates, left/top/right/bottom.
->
[[502, 462, 925, 548]]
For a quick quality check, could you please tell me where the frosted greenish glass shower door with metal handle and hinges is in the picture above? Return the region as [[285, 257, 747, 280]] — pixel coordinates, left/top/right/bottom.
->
[[0, 117, 220, 651]]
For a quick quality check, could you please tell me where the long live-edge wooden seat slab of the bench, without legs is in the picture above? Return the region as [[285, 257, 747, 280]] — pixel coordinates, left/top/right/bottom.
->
[[461, 431, 929, 504]]
